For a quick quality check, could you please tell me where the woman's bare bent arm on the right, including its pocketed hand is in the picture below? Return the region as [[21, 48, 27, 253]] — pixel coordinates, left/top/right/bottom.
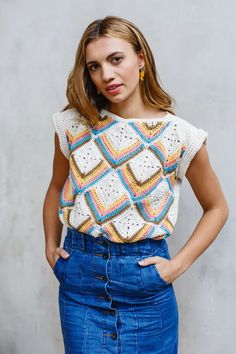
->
[[138, 144, 229, 282]]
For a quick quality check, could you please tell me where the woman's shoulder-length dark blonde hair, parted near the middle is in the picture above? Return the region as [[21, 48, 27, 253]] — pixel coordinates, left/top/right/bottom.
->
[[63, 16, 175, 125]]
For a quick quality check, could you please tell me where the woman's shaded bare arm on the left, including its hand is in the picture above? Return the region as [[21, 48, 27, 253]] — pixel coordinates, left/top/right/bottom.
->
[[43, 133, 69, 268]]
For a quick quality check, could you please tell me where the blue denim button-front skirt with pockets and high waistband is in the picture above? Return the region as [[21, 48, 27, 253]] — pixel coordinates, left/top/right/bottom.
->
[[53, 228, 178, 354]]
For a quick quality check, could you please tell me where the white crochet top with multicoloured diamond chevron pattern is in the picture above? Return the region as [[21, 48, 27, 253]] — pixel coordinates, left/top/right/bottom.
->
[[53, 108, 208, 243]]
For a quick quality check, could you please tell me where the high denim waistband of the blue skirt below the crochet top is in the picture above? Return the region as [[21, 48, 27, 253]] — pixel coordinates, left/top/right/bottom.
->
[[65, 227, 168, 256]]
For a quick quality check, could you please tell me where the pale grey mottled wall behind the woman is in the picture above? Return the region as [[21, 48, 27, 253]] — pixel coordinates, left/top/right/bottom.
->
[[0, 0, 236, 354]]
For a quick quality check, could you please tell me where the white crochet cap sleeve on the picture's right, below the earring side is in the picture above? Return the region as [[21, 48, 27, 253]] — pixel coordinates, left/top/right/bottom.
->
[[177, 120, 208, 180]]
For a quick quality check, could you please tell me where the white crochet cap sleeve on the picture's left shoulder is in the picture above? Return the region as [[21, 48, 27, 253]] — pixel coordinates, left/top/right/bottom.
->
[[52, 112, 70, 159]]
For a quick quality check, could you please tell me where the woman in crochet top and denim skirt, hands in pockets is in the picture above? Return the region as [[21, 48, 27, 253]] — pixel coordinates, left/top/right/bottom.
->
[[43, 16, 228, 354]]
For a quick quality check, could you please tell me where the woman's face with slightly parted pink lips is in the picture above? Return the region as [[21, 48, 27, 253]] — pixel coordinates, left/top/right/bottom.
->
[[85, 36, 144, 108]]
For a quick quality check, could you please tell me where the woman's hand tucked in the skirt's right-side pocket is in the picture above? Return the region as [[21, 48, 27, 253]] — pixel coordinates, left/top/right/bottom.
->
[[138, 256, 181, 283]]
